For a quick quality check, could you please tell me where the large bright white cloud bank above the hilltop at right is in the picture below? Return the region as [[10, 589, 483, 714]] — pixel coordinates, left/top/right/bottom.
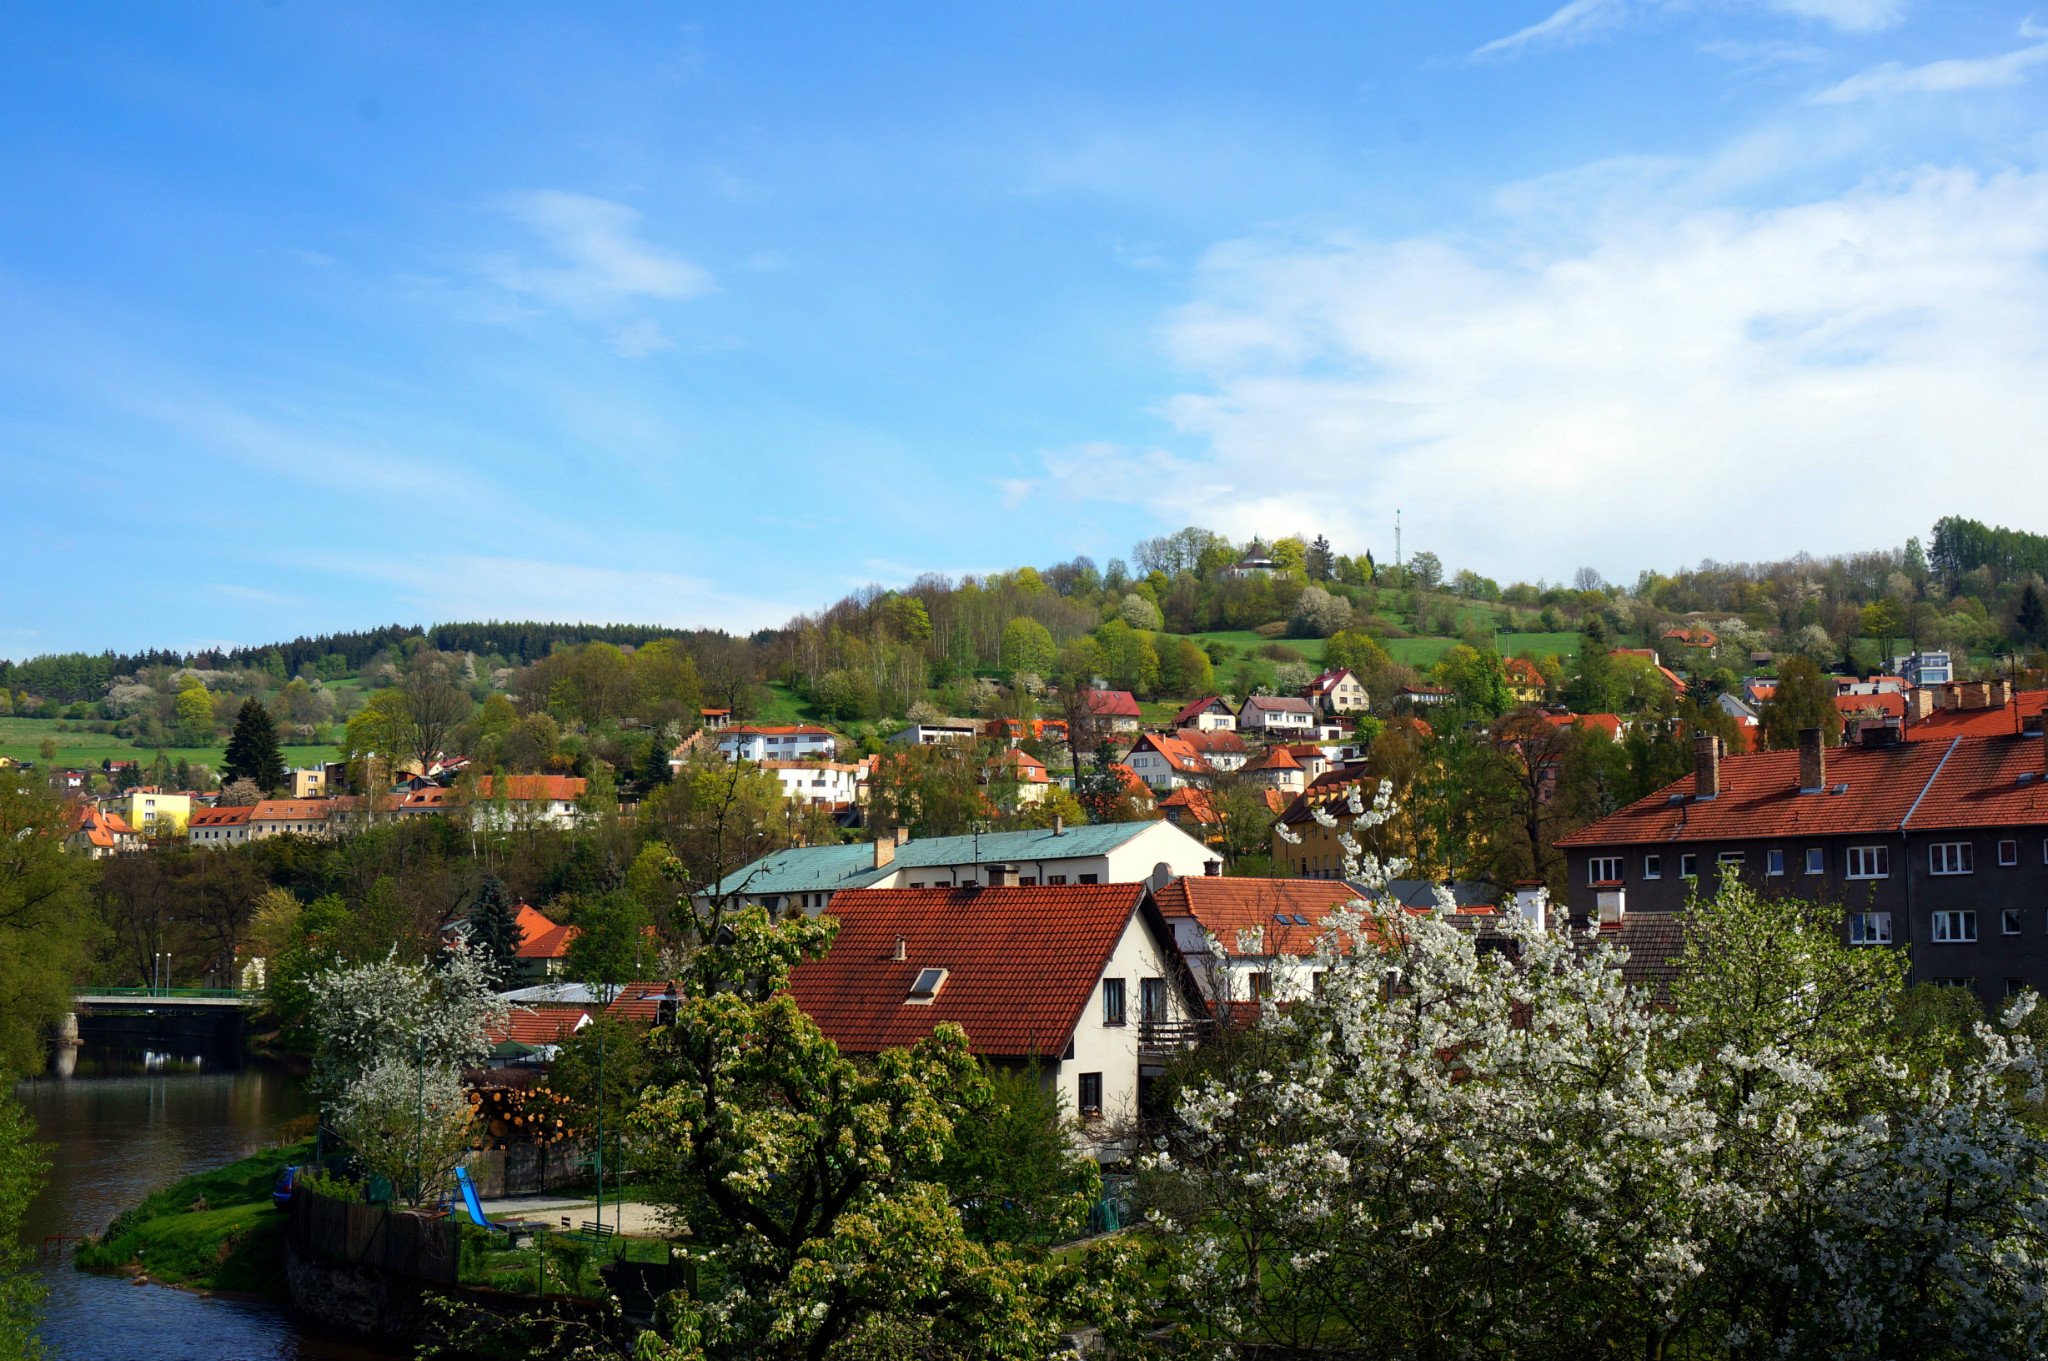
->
[[1047, 163, 2048, 575]]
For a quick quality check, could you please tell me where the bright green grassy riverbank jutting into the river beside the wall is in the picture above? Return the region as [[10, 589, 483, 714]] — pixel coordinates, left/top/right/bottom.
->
[[76, 1140, 313, 1300]]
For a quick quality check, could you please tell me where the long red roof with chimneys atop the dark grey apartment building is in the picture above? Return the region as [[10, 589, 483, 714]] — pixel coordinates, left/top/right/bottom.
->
[[1559, 735, 2048, 847]]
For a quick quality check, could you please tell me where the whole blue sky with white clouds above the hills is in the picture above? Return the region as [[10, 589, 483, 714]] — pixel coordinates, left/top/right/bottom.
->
[[0, 0, 2048, 657]]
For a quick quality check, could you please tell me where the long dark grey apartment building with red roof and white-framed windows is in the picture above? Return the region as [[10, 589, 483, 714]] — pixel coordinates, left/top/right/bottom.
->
[[1559, 729, 2048, 1005]]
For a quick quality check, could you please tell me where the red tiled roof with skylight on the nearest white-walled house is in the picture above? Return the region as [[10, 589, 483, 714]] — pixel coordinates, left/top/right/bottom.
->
[[788, 884, 1178, 1058]]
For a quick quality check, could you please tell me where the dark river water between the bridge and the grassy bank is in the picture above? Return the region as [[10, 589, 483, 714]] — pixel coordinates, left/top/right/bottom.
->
[[14, 1044, 403, 1361]]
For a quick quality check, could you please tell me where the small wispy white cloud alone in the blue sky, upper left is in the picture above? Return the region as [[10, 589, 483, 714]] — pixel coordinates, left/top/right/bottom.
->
[[485, 188, 713, 313]]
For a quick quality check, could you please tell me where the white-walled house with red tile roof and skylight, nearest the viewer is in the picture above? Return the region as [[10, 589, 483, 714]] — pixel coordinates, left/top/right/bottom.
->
[[788, 884, 1208, 1129]]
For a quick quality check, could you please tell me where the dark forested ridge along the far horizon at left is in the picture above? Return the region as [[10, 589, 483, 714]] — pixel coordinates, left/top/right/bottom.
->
[[0, 620, 725, 702]]
